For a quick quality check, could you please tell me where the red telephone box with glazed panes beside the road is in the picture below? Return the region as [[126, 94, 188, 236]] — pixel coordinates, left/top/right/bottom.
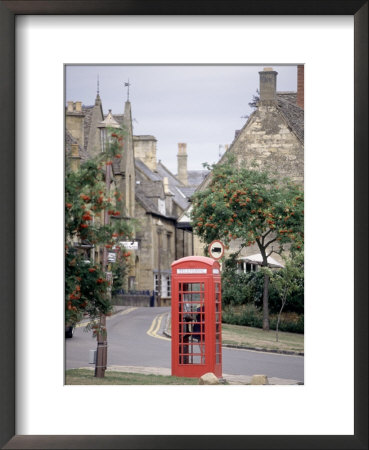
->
[[172, 256, 222, 378]]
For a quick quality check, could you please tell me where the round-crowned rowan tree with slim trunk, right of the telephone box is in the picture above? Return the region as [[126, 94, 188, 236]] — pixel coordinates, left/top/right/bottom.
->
[[191, 158, 304, 330]]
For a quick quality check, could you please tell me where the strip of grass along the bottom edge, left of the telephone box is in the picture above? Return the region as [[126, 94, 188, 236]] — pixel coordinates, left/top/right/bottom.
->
[[65, 369, 198, 385]]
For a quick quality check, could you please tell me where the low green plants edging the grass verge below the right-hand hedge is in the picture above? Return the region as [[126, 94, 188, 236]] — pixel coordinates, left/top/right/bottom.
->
[[222, 304, 304, 333]]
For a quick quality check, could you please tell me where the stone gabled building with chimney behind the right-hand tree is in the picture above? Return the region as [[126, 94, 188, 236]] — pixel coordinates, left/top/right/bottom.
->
[[188, 65, 304, 261]]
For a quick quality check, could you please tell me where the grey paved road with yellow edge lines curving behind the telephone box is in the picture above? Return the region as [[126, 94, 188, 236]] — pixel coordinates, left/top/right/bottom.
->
[[66, 308, 304, 382]]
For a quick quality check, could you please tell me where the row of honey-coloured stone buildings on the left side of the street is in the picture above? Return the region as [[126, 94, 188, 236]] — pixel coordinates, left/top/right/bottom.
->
[[65, 93, 207, 304]]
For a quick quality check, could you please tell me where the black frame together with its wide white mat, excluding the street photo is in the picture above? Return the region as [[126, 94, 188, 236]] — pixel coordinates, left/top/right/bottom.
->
[[0, 0, 368, 449]]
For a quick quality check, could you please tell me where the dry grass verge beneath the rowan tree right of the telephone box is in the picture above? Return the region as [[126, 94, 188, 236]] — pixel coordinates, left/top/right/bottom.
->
[[222, 323, 304, 353]]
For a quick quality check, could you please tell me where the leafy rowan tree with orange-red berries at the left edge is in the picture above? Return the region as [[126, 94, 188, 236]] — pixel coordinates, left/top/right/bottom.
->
[[65, 130, 132, 334]]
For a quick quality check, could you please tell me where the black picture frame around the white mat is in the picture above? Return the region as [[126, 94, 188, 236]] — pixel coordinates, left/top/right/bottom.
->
[[0, 0, 368, 450]]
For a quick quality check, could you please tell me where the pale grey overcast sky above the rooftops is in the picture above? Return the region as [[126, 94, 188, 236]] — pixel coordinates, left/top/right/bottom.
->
[[65, 64, 297, 174]]
